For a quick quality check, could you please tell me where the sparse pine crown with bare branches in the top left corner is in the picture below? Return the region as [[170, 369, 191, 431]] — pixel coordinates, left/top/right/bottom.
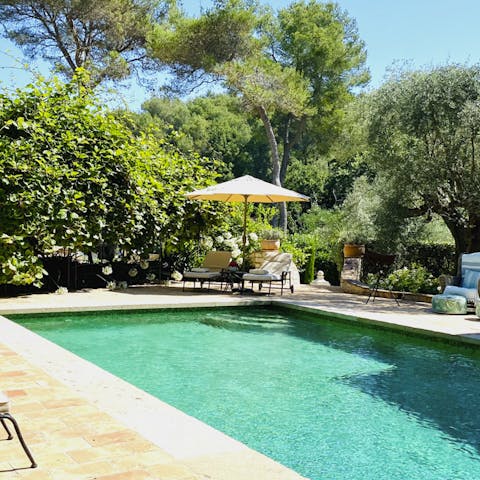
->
[[0, 0, 169, 84]]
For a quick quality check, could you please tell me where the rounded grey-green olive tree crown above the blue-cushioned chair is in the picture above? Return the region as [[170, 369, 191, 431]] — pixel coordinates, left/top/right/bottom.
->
[[368, 65, 480, 254]]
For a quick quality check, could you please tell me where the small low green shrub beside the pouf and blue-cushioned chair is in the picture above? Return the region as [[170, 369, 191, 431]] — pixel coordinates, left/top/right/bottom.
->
[[367, 263, 439, 294]]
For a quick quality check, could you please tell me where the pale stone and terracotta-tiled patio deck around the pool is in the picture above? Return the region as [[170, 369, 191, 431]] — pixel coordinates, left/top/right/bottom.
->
[[0, 287, 480, 480]]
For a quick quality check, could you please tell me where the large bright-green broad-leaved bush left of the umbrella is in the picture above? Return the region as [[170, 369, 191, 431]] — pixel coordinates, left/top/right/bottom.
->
[[0, 77, 222, 283]]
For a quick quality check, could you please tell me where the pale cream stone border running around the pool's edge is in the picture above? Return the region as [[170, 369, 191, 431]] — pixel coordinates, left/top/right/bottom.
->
[[0, 287, 480, 480]]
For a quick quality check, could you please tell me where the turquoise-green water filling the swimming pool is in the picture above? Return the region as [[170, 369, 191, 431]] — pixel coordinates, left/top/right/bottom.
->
[[12, 308, 480, 480]]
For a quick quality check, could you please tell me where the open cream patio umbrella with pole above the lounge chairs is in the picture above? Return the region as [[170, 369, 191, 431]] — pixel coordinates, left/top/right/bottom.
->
[[186, 175, 310, 259]]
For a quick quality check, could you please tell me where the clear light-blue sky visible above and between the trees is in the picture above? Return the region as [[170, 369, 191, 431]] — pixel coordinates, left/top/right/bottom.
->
[[0, 0, 480, 109]]
